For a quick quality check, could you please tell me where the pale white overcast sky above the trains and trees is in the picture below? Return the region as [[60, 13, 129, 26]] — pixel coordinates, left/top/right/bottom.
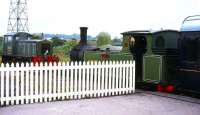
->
[[0, 0, 200, 37]]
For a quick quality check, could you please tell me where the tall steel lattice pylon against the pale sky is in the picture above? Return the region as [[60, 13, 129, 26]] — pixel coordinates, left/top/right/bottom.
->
[[7, 0, 29, 33]]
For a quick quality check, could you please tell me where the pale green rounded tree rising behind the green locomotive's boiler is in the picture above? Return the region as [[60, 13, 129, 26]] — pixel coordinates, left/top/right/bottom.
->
[[97, 32, 111, 46]]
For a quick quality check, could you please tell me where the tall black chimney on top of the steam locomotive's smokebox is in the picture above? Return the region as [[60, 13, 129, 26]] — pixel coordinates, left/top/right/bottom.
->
[[79, 27, 88, 45]]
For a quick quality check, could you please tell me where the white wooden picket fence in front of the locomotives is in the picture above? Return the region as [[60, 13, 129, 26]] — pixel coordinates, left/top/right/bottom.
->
[[0, 61, 135, 106]]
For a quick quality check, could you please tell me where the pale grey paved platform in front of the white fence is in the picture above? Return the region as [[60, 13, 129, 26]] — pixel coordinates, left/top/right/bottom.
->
[[0, 92, 200, 115]]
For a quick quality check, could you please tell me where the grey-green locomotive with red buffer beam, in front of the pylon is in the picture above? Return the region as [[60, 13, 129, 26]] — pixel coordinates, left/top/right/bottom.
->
[[2, 32, 59, 63]]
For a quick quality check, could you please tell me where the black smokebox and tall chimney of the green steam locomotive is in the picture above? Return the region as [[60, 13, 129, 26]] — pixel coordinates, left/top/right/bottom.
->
[[70, 27, 97, 61]]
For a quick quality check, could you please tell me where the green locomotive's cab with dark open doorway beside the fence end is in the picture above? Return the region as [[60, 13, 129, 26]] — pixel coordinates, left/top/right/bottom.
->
[[122, 31, 151, 82]]
